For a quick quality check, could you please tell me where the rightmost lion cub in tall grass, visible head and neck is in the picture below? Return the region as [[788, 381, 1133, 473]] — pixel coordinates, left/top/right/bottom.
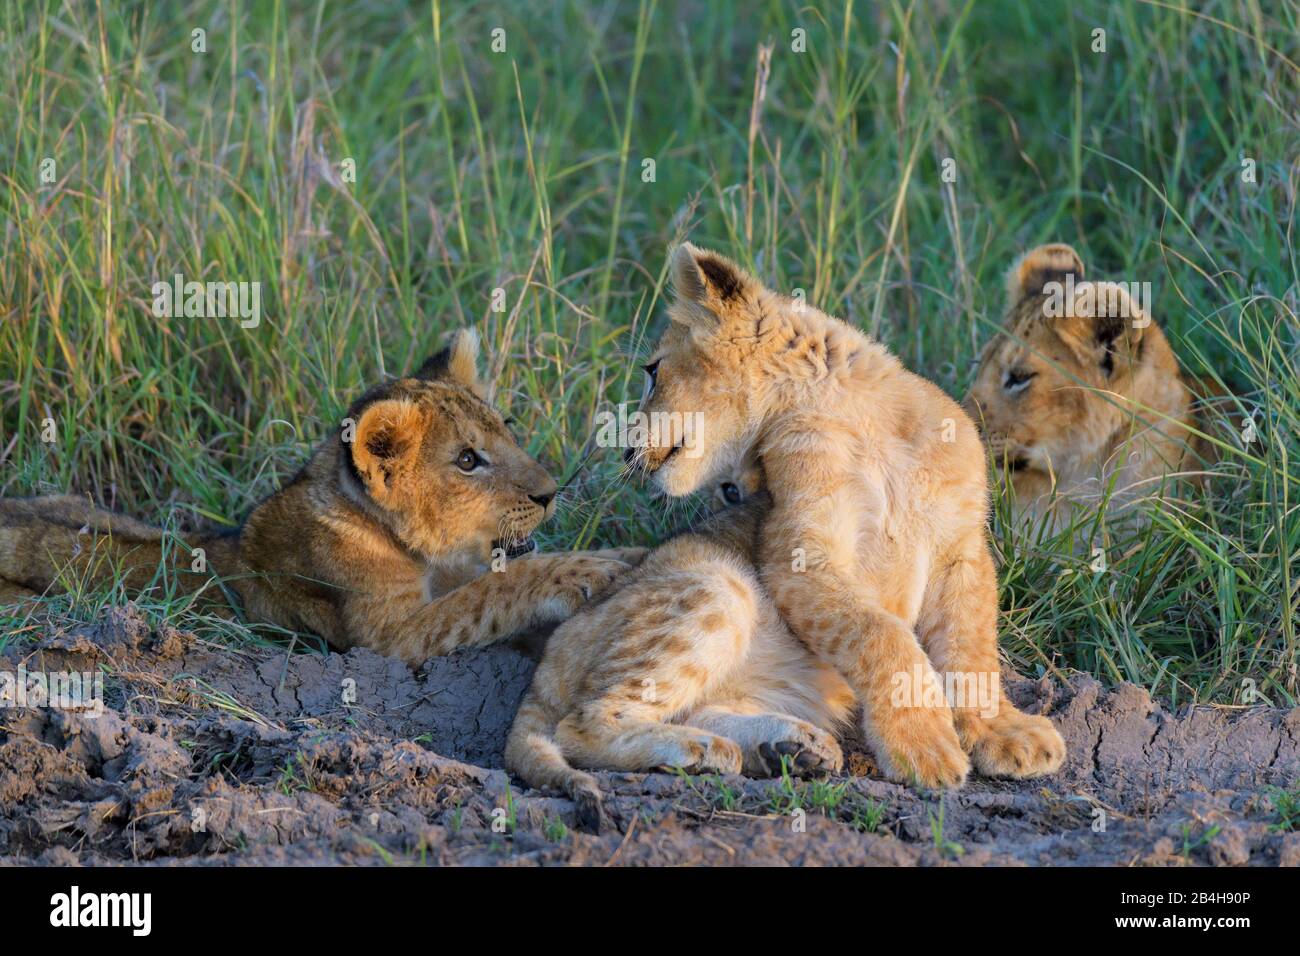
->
[[966, 243, 1234, 527]]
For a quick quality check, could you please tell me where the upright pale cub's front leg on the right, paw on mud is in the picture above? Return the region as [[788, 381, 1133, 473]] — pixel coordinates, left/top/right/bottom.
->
[[917, 536, 1065, 779]]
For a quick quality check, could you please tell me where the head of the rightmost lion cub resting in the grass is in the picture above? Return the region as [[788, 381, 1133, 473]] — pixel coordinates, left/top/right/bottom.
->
[[966, 243, 1190, 515]]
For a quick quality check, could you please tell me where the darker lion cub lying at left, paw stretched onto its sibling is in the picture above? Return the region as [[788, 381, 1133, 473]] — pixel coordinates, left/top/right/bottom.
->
[[0, 332, 644, 665]]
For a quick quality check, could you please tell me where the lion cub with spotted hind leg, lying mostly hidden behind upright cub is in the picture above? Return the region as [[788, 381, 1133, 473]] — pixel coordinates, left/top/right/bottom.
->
[[506, 464, 854, 826]]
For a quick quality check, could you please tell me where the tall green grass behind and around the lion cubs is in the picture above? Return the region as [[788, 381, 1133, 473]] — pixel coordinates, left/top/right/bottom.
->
[[0, 0, 1300, 704]]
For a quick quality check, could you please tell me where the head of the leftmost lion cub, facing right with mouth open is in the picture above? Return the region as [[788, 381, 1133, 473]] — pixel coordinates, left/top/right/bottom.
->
[[339, 330, 555, 559]]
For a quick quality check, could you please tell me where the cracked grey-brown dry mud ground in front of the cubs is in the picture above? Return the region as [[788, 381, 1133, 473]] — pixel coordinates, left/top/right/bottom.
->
[[0, 606, 1300, 865]]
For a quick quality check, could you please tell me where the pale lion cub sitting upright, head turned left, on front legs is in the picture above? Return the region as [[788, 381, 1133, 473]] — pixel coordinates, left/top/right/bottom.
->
[[621, 245, 1065, 787]]
